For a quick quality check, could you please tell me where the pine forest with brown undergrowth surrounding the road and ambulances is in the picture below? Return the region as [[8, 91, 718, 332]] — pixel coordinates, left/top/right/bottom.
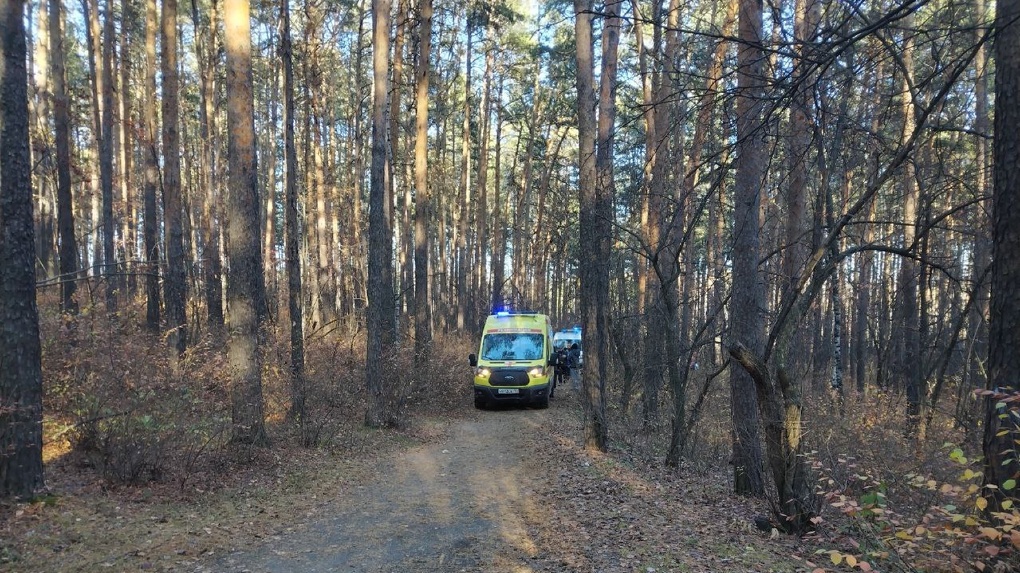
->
[[0, 0, 1020, 571]]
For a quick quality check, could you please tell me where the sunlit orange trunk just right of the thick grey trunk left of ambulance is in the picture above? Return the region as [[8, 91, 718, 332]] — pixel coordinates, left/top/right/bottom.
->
[[414, 0, 435, 371]]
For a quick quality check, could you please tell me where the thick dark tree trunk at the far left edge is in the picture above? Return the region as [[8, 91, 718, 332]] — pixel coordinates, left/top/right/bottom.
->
[[0, 0, 45, 498]]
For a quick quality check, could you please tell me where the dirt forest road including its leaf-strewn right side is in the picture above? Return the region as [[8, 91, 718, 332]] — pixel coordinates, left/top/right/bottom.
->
[[189, 390, 799, 573]]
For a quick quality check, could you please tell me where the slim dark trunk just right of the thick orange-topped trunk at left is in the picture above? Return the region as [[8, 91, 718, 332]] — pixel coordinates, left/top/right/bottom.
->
[[279, 0, 308, 436]]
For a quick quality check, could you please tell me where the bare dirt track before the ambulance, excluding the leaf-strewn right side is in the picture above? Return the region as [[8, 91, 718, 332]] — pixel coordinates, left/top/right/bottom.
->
[[197, 405, 561, 573]]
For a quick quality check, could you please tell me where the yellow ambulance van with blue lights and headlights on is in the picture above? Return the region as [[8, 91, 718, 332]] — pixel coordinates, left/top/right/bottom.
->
[[468, 311, 553, 408]]
